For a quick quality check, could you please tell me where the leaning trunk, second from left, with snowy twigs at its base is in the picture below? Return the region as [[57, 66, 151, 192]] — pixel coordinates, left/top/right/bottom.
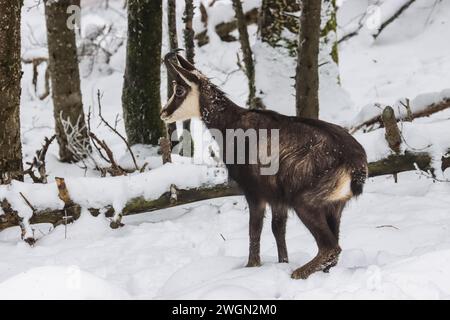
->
[[45, 0, 90, 162]]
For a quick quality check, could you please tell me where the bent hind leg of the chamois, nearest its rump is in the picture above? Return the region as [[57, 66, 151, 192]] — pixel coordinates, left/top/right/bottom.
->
[[292, 207, 341, 279]]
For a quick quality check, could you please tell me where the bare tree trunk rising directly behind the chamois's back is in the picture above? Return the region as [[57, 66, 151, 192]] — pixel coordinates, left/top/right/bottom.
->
[[295, 0, 322, 119]]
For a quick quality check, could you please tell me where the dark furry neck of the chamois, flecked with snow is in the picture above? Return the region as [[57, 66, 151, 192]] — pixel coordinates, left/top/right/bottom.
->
[[200, 82, 245, 131]]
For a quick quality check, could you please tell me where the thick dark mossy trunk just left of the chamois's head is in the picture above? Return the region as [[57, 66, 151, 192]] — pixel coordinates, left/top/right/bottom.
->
[[122, 0, 165, 145]]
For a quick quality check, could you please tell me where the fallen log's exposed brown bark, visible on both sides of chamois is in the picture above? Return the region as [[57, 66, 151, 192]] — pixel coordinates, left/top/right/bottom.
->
[[0, 150, 450, 235]]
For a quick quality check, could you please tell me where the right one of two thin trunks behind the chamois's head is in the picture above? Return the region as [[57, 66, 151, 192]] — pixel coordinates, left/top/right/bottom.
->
[[182, 0, 195, 156]]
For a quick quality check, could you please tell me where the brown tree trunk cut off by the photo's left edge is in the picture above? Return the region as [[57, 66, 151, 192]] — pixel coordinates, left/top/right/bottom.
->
[[0, 0, 23, 184]]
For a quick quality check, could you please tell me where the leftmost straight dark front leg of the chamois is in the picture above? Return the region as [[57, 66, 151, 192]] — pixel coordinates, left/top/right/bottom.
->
[[246, 196, 266, 267]]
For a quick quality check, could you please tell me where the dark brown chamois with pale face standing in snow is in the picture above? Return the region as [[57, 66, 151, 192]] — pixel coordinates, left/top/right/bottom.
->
[[161, 52, 367, 279]]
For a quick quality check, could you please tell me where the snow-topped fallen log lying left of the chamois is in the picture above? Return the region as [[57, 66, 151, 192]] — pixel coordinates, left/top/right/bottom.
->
[[0, 163, 230, 239]]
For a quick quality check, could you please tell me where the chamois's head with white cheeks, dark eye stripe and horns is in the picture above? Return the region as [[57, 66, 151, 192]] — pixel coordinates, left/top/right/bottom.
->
[[160, 52, 204, 123]]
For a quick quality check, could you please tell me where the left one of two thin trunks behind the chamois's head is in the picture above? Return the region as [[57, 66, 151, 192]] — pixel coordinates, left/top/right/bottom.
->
[[167, 0, 178, 149]]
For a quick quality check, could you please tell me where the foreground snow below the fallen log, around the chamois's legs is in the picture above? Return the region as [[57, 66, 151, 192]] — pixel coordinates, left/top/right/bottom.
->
[[0, 172, 450, 299]]
